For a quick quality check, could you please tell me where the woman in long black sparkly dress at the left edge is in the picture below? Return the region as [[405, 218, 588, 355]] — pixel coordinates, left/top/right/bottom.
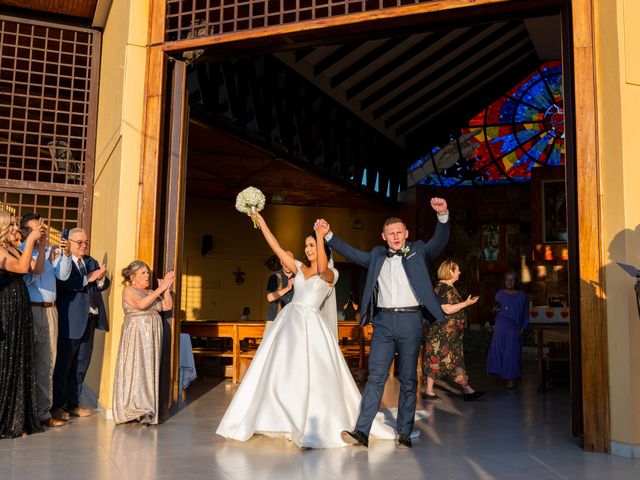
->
[[0, 210, 44, 438]]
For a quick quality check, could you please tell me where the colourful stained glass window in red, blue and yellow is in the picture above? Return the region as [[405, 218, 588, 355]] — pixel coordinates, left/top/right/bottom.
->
[[407, 61, 564, 186]]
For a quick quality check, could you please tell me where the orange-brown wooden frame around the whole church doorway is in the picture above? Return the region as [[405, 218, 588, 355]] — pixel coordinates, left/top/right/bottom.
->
[[137, 0, 611, 452]]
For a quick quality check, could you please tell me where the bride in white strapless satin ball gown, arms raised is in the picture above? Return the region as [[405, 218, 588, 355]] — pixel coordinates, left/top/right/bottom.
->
[[216, 213, 395, 448]]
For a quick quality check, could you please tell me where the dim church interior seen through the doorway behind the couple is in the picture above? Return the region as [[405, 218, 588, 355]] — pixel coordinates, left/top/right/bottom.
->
[[180, 9, 572, 404]]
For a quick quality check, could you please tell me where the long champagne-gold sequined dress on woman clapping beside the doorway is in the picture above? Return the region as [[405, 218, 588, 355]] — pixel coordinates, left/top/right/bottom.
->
[[113, 290, 162, 424]]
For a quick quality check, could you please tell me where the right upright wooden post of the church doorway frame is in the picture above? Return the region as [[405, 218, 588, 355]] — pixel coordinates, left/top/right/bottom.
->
[[572, 0, 611, 452]]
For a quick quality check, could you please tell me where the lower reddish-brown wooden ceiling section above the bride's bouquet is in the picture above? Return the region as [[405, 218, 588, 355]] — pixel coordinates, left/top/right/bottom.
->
[[187, 121, 390, 208]]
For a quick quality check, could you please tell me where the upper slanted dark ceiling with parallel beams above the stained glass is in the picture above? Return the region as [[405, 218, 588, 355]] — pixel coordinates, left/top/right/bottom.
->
[[276, 16, 560, 155]]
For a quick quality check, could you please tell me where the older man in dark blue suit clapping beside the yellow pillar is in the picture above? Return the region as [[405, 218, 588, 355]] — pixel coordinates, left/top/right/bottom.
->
[[51, 228, 110, 420]]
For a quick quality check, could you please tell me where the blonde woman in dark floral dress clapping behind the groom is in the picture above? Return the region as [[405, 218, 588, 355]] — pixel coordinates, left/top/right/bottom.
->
[[422, 260, 485, 402]]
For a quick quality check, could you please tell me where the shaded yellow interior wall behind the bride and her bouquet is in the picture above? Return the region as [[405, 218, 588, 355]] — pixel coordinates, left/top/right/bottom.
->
[[182, 195, 392, 320]]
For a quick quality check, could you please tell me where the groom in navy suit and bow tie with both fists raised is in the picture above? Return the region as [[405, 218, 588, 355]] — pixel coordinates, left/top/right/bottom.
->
[[316, 198, 449, 448]]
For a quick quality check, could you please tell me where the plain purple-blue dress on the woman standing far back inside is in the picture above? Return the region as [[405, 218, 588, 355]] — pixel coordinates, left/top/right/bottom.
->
[[487, 290, 529, 380]]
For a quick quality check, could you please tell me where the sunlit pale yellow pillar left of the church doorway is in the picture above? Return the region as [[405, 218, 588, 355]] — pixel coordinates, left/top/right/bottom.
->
[[85, 0, 148, 409]]
